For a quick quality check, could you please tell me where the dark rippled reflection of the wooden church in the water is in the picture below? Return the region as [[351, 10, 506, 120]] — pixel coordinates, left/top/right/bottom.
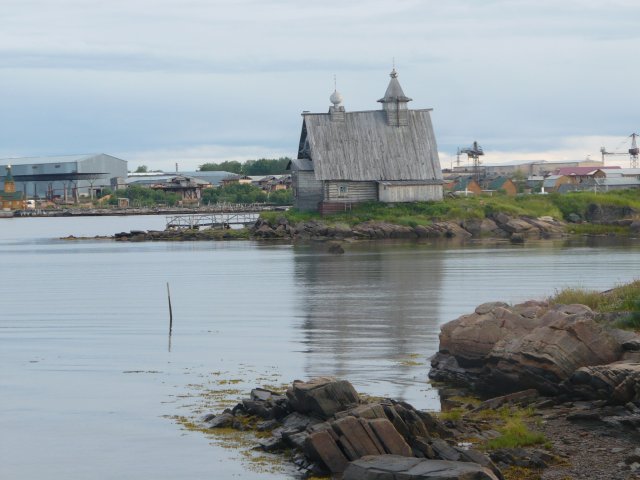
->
[[294, 244, 443, 400]]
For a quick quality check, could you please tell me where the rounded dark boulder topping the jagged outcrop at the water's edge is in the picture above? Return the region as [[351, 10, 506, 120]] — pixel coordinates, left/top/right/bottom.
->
[[287, 377, 360, 419]]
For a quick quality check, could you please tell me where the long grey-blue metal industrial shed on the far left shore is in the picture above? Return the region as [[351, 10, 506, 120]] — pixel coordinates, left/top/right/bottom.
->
[[0, 153, 127, 201]]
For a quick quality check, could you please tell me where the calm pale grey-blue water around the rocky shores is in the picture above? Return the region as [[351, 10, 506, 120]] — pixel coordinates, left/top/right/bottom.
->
[[0, 216, 640, 479]]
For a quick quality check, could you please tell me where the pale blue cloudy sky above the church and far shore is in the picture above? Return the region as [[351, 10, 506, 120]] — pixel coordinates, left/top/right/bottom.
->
[[0, 0, 640, 171]]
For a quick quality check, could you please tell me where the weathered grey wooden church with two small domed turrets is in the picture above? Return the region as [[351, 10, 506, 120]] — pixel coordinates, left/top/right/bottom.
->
[[287, 69, 443, 213]]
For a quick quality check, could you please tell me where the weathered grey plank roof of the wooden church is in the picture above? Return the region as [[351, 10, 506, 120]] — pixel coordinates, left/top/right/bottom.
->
[[298, 109, 442, 181]]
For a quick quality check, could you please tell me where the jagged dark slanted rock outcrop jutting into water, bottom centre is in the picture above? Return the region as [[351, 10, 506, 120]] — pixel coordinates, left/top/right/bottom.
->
[[202, 377, 502, 479]]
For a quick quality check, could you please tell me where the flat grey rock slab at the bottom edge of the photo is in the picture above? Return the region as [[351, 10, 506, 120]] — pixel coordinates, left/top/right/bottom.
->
[[343, 455, 498, 480]]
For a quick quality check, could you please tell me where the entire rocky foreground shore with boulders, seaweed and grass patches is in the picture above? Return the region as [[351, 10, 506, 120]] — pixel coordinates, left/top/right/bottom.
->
[[199, 301, 640, 480]]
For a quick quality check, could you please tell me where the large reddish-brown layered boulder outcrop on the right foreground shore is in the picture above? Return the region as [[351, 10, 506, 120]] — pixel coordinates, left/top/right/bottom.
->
[[429, 301, 637, 401]]
